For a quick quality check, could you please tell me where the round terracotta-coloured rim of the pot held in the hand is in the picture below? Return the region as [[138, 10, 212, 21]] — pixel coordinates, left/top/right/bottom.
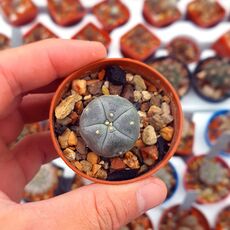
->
[[49, 58, 183, 184]]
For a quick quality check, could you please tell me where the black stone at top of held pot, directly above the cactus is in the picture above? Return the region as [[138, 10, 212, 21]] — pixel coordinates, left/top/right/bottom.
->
[[105, 65, 126, 85]]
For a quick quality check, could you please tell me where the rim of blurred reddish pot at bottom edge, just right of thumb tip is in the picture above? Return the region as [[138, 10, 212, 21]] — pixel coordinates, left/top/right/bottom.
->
[[158, 205, 210, 230]]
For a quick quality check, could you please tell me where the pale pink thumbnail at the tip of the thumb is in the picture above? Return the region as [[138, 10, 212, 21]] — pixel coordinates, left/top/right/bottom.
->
[[137, 178, 166, 214]]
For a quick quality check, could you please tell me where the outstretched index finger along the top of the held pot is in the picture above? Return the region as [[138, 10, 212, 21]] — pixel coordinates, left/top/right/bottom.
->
[[0, 39, 106, 117]]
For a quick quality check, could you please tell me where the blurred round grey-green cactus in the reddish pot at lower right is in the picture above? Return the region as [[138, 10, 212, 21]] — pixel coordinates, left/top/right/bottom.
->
[[199, 159, 225, 185]]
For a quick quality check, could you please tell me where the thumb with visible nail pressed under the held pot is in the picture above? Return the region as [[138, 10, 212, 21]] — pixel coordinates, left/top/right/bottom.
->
[[20, 177, 166, 230]]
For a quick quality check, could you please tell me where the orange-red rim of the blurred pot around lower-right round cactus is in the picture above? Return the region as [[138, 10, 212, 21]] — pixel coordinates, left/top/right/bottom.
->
[[183, 154, 230, 205]]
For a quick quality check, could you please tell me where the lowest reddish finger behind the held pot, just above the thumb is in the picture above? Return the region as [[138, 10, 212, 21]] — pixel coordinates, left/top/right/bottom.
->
[[0, 132, 57, 201]]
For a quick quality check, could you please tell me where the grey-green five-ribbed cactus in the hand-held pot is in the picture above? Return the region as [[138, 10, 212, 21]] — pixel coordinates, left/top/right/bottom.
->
[[80, 96, 140, 157]]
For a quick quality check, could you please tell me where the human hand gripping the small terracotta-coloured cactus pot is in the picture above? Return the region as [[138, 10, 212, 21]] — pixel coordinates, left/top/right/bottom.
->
[[0, 39, 166, 230]]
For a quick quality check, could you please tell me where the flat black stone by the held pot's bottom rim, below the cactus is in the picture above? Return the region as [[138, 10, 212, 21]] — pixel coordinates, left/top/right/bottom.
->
[[107, 169, 138, 181]]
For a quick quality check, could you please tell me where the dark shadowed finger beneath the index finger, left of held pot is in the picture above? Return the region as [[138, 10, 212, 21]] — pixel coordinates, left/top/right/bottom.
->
[[19, 93, 53, 123]]
